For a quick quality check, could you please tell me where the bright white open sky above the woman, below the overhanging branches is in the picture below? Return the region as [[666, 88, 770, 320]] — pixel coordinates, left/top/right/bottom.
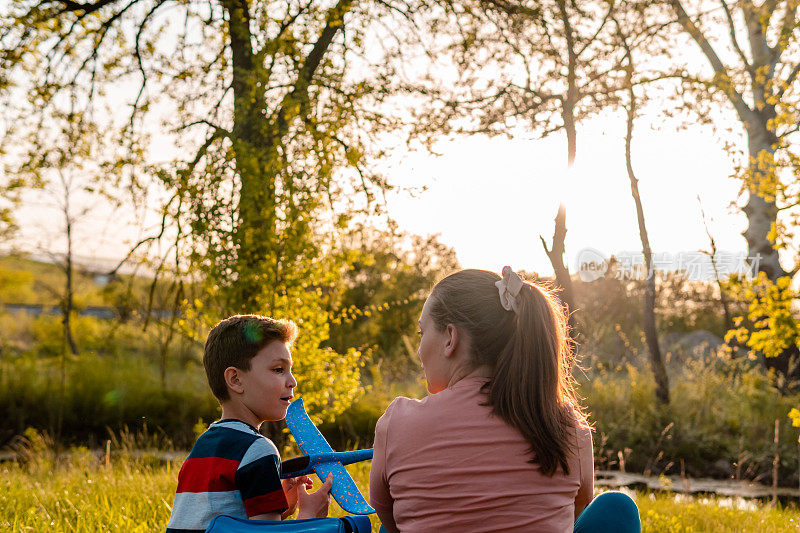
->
[[388, 114, 746, 274]]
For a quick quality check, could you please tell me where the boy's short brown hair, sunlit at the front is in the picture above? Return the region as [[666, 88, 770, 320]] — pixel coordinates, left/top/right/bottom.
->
[[203, 315, 297, 401]]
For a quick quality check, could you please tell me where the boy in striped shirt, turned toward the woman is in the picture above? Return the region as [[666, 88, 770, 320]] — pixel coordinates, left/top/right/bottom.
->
[[167, 315, 332, 533]]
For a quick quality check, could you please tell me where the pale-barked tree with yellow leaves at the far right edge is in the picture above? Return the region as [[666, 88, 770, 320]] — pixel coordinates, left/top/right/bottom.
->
[[656, 0, 800, 377]]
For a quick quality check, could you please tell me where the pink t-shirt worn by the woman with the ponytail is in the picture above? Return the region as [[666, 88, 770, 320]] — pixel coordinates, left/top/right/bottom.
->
[[370, 378, 594, 533]]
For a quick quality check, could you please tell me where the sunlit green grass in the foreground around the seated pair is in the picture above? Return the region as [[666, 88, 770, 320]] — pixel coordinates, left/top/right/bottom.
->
[[0, 452, 800, 533]]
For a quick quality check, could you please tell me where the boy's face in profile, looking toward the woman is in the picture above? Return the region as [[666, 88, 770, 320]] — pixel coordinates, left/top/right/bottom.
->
[[239, 341, 297, 423]]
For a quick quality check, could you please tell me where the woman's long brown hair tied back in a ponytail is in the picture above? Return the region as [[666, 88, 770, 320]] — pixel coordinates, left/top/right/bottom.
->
[[430, 270, 585, 476]]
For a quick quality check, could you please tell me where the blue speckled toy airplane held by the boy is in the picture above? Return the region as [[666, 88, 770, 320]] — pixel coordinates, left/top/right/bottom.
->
[[281, 399, 375, 515]]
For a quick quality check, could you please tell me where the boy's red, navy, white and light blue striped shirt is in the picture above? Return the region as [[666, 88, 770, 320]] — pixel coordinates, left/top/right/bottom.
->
[[167, 419, 288, 533]]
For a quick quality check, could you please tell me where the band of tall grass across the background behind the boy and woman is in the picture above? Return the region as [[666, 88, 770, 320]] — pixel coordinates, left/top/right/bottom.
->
[[0, 340, 800, 486]]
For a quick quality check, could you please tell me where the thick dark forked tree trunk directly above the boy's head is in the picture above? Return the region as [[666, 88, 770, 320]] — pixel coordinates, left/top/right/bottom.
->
[[223, 0, 353, 313]]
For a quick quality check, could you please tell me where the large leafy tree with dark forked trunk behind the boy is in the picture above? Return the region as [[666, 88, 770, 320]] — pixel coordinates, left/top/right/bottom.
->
[[0, 0, 418, 420]]
